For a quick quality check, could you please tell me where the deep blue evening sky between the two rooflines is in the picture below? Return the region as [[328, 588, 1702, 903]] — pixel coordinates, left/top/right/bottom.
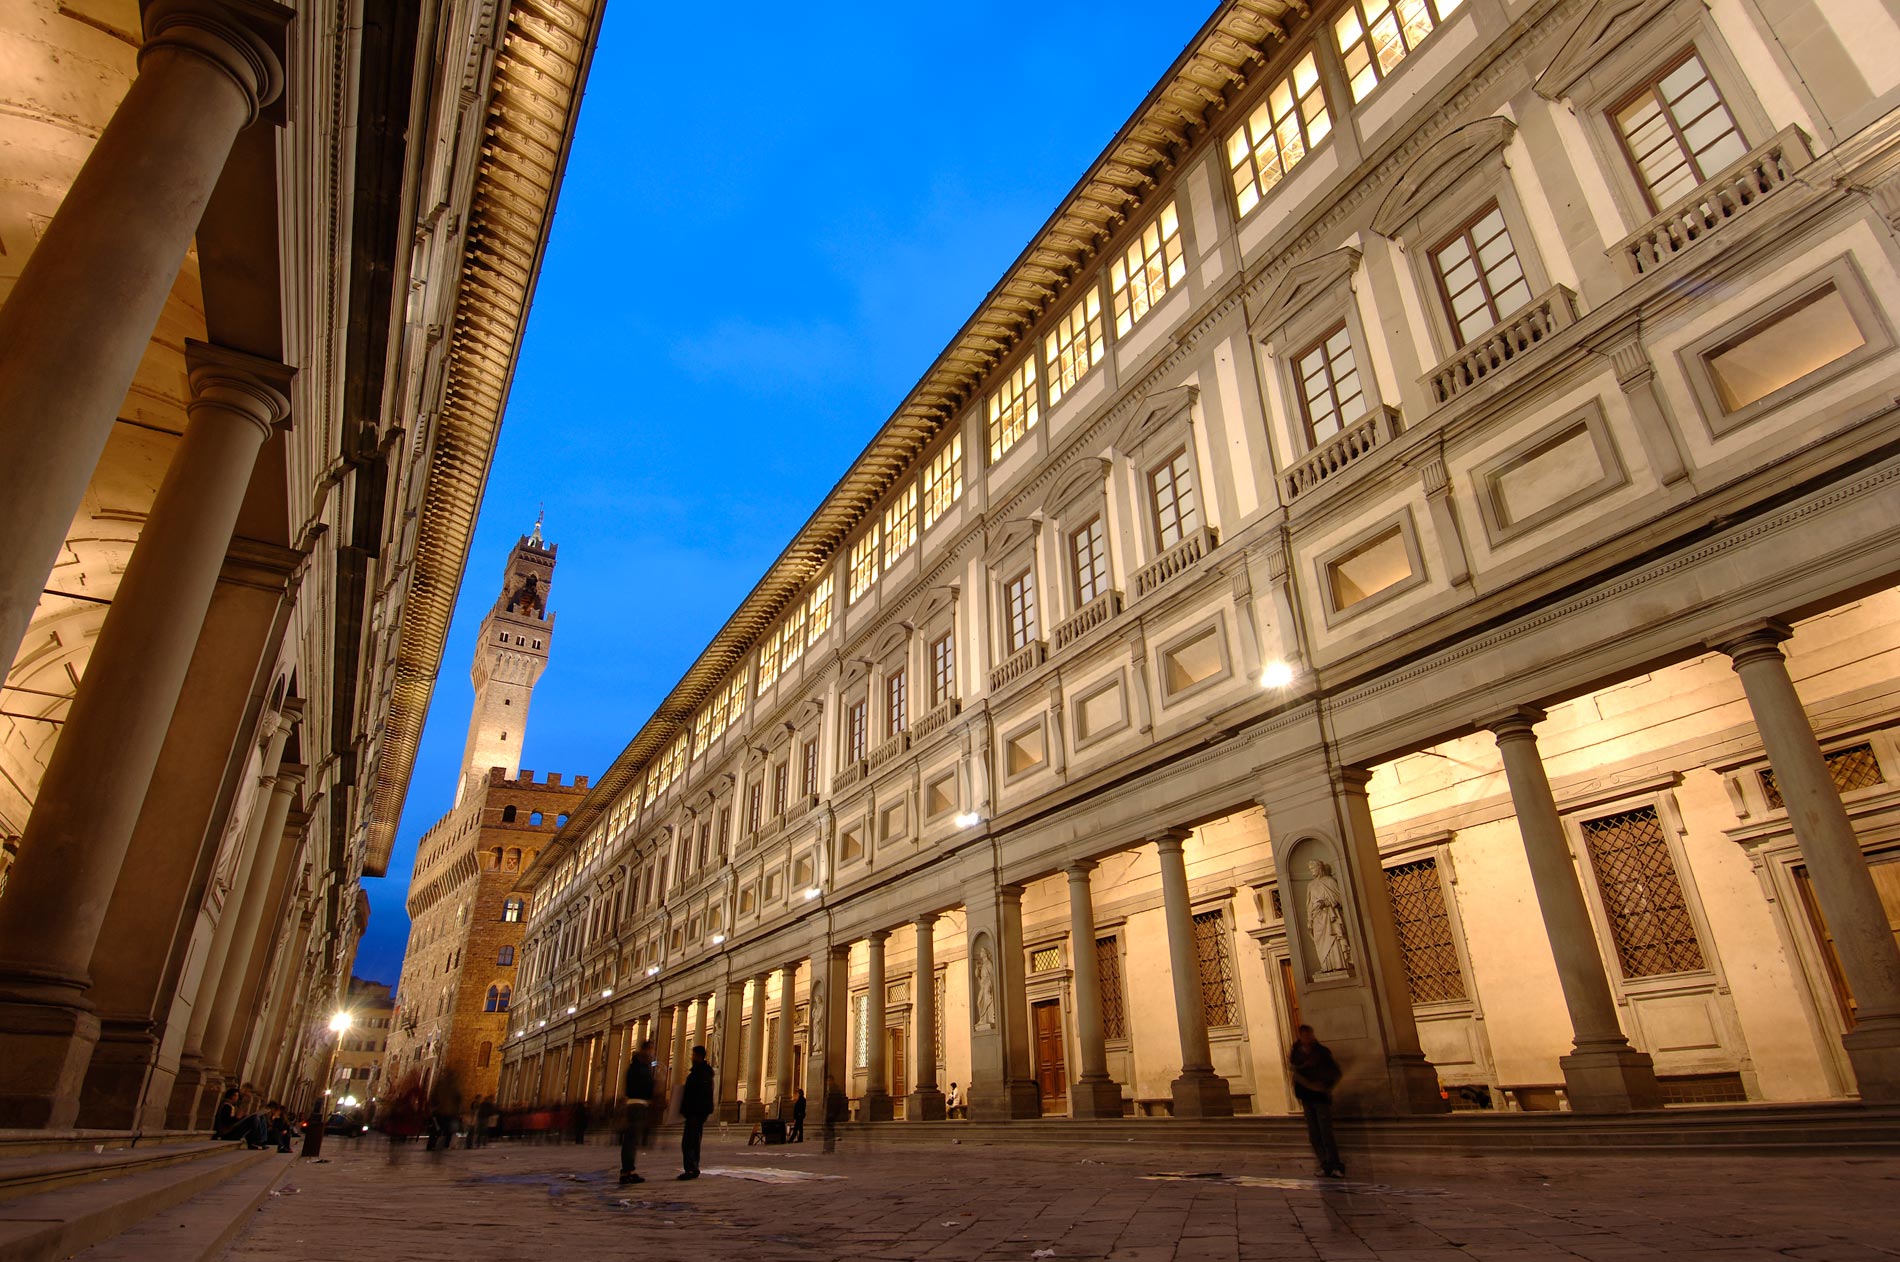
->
[[355, 0, 1212, 983]]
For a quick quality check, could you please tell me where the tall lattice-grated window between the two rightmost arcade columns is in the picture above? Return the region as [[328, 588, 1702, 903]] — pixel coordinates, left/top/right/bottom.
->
[[1583, 806, 1706, 977]]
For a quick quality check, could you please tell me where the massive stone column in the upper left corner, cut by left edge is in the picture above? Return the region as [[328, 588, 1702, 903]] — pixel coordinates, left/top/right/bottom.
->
[[0, 0, 289, 676]]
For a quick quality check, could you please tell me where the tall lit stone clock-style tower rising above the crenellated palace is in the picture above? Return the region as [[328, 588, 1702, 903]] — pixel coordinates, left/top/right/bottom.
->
[[456, 517, 559, 804]]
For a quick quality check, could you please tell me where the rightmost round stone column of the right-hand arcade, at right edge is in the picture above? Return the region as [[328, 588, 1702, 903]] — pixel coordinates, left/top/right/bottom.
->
[[1718, 621, 1900, 1100]]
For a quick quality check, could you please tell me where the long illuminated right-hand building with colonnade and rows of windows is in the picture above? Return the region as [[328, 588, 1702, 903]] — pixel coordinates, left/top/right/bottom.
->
[[497, 0, 1900, 1119]]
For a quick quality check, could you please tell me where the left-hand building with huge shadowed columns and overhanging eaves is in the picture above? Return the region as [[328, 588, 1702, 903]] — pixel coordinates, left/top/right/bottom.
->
[[0, 0, 600, 1142]]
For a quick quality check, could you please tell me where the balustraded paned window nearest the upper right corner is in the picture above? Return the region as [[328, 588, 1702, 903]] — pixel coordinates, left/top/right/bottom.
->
[[1609, 48, 1748, 211]]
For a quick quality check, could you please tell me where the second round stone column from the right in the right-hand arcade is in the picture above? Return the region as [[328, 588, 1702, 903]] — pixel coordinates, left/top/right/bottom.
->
[[1482, 707, 1663, 1114]]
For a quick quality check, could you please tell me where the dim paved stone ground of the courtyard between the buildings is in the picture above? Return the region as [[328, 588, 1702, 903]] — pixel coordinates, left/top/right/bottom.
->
[[215, 1137, 1900, 1262]]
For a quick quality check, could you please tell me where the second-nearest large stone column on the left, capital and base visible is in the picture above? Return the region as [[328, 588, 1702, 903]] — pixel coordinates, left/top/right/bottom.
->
[[0, 340, 289, 1129]]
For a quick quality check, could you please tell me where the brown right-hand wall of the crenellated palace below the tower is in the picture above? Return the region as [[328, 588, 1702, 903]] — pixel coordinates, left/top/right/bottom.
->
[[439, 768, 587, 1100]]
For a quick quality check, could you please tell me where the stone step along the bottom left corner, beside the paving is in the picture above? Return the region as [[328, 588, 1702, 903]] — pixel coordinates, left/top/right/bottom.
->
[[0, 1144, 277, 1262]]
